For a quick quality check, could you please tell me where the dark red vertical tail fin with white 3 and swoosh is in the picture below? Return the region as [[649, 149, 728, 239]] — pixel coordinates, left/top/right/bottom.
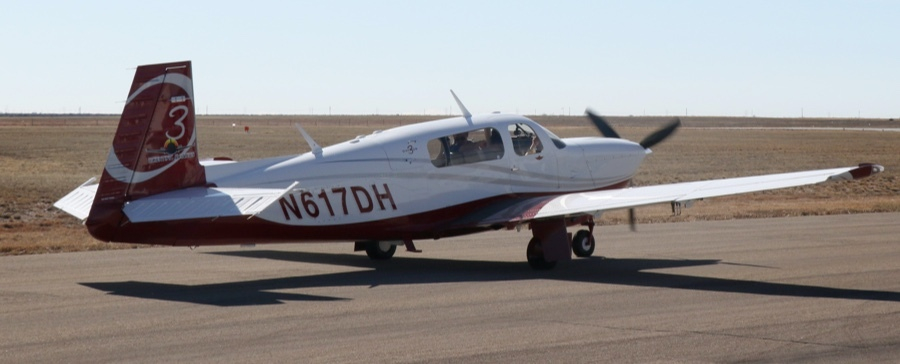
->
[[85, 61, 206, 241]]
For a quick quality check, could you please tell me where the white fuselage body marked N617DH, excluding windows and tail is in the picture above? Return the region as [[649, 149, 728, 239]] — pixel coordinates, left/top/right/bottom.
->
[[192, 114, 646, 240]]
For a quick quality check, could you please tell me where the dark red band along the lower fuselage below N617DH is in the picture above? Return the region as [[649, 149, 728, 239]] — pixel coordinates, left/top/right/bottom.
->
[[112, 181, 628, 245]]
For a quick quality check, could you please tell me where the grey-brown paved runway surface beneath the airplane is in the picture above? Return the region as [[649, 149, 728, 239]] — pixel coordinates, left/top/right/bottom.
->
[[0, 213, 900, 363]]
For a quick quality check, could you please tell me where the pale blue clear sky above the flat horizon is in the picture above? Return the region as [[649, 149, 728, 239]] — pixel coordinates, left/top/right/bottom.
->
[[0, 0, 900, 118]]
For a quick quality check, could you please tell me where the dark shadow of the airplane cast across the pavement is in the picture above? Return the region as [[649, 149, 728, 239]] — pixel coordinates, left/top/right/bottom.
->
[[80, 250, 900, 307]]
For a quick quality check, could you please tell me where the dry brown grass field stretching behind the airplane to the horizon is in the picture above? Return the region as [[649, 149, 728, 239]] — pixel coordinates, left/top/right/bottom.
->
[[0, 115, 900, 255]]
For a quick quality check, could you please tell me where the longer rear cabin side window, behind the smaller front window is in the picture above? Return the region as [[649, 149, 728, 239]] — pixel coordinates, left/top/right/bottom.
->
[[428, 128, 503, 168]]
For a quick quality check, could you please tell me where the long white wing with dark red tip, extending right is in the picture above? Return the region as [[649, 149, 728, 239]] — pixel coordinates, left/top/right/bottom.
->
[[460, 164, 884, 226]]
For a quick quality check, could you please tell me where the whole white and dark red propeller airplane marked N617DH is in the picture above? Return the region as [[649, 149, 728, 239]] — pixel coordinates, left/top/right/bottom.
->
[[54, 61, 884, 270]]
